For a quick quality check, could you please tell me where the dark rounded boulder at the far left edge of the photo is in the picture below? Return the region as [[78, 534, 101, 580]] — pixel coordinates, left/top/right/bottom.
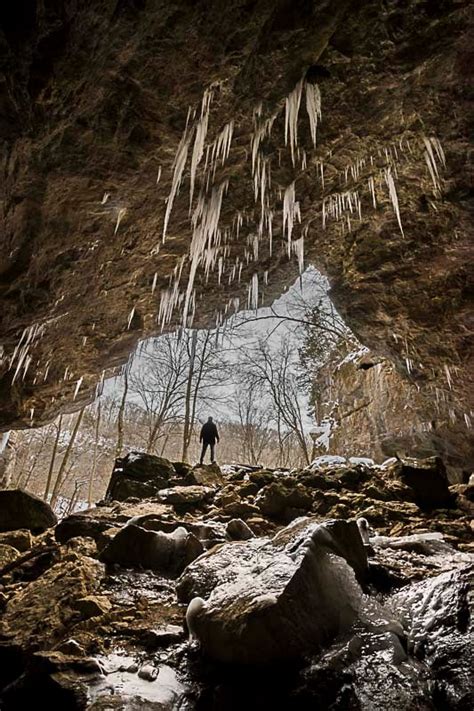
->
[[0, 489, 58, 533]]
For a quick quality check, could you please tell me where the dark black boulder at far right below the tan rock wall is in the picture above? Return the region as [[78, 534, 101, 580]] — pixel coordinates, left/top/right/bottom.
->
[[390, 457, 453, 509]]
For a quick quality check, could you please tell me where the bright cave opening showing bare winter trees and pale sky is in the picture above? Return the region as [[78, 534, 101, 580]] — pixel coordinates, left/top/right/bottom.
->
[[3, 267, 362, 515]]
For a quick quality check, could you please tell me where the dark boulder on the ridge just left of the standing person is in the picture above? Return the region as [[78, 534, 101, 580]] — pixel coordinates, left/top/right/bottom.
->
[[105, 452, 177, 501]]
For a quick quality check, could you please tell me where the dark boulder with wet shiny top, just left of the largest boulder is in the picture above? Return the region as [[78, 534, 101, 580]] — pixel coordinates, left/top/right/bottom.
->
[[100, 524, 204, 574]]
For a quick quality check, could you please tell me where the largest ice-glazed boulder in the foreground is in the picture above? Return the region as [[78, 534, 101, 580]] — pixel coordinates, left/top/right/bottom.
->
[[177, 519, 367, 664]]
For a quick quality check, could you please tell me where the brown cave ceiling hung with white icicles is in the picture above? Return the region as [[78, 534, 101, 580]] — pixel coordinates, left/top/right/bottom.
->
[[0, 0, 474, 466]]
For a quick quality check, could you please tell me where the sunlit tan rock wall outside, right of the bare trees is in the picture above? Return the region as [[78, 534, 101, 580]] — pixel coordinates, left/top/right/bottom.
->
[[314, 347, 467, 476]]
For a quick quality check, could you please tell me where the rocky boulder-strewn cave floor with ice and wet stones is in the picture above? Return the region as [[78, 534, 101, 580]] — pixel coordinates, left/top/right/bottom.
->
[[0, 453, 474, 710]]
